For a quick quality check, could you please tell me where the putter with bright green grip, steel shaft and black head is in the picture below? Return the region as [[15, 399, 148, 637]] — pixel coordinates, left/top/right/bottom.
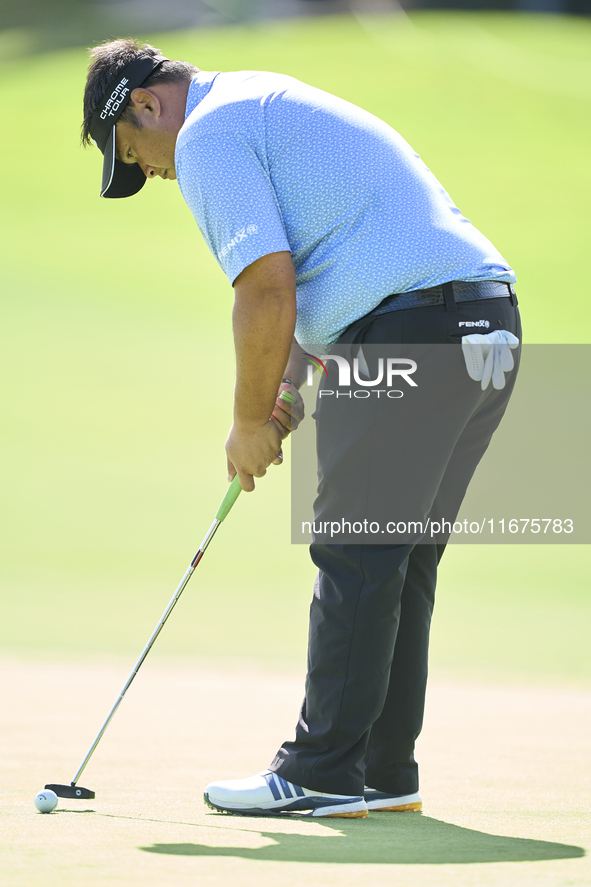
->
[[45, 475, 241, 800]]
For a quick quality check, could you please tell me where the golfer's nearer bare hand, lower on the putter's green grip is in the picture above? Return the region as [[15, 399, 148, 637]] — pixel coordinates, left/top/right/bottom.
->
[[226, 419, 289, 493]]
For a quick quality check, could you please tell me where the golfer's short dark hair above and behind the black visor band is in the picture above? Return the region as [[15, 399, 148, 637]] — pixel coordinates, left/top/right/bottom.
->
[[81, 39, 199, 145]]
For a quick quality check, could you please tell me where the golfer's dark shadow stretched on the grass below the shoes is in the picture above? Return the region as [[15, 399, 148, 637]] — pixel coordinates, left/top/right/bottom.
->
[[139, 814, 585, 865]]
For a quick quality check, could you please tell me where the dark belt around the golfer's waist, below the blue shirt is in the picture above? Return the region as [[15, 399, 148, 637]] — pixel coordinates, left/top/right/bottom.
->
[[374, 280, 517, 318]]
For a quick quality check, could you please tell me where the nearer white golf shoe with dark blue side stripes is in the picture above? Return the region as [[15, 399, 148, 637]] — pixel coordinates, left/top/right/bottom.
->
[[203, 770, 367, 819]]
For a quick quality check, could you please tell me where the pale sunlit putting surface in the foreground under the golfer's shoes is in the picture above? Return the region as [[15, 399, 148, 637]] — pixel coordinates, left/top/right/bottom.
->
[[0, 658, 591, 887]]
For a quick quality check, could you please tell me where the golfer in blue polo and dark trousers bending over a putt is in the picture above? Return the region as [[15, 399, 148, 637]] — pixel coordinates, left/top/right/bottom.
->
[[82, 40, 521, 817]]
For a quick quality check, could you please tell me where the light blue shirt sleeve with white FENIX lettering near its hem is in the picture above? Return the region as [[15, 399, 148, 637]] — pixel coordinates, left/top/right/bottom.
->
[[175, 132, 291, 283]]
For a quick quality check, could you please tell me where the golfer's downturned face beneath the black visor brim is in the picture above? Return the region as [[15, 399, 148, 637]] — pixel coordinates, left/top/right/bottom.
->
[[115, 120, 176, 179]]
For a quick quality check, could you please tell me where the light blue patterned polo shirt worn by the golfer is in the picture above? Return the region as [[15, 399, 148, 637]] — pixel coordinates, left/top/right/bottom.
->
[[175, 71, 515, 344]]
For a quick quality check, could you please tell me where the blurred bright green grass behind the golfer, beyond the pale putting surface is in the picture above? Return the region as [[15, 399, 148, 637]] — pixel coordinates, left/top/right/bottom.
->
[[0, 12, 591, 681]]
